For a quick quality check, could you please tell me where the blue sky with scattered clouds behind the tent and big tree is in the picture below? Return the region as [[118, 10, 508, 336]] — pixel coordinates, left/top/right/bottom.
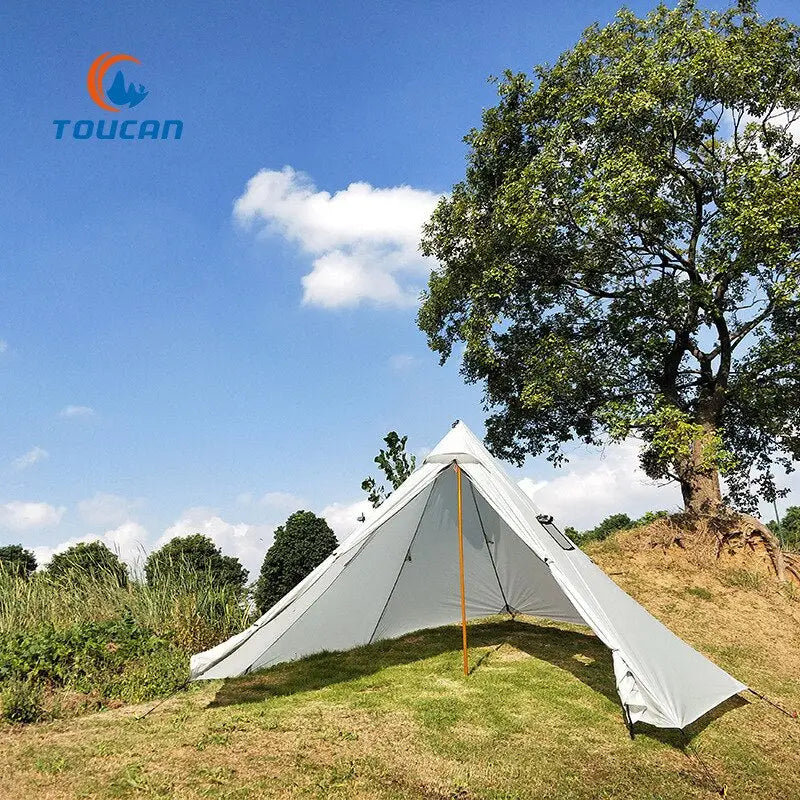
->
[[0, 2, 793, 567]]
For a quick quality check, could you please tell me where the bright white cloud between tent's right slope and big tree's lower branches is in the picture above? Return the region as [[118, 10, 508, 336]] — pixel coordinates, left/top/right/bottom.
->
[[519, 440, 682, 530]]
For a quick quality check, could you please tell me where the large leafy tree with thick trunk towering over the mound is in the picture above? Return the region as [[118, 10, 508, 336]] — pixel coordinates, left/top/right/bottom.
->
[[418, 0, 800, 520]]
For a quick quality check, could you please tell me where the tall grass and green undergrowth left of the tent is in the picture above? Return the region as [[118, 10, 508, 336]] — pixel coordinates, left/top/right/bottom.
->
[[0, 565, 252, 722]]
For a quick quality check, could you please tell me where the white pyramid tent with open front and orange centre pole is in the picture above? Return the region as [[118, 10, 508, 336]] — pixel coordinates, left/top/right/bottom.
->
[[191, 422, 747, 730]]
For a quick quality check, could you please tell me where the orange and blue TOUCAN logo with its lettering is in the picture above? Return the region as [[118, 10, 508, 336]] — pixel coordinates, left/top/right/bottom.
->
[[53, 51, 183, 141]]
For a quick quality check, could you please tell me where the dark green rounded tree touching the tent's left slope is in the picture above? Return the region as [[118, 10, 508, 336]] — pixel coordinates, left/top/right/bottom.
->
[[255, 511, 338, 614]]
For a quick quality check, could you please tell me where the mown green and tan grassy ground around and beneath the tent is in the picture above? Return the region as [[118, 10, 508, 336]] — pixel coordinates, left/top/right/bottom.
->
[[0, 530, 800, 800]]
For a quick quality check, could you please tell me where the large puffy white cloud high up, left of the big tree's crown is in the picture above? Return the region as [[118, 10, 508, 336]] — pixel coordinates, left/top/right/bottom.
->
[[233, 166, 439, 308]]
